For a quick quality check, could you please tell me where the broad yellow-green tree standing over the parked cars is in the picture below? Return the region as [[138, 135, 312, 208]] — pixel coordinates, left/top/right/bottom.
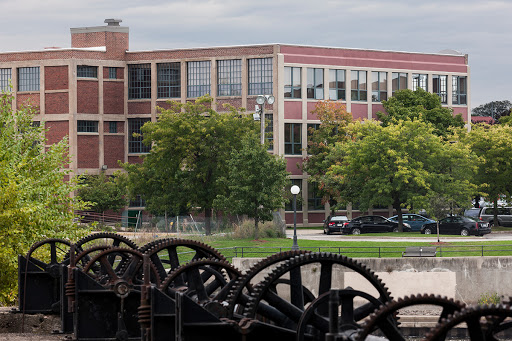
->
[[327, 119, 476, 229]]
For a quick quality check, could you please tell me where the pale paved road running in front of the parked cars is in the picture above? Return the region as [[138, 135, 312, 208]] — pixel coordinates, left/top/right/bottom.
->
[[286, 229, 512, 243]]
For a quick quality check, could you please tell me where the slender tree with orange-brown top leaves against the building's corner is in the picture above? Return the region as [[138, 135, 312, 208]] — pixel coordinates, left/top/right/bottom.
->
[[301, 101, 353, 210]]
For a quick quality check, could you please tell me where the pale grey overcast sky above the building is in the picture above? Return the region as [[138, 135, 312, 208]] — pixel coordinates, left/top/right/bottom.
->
[[0, 0, 512, 108]]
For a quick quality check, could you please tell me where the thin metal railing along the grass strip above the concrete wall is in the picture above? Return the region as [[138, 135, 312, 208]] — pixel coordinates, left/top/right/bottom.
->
[[218, 245, 512, 258]]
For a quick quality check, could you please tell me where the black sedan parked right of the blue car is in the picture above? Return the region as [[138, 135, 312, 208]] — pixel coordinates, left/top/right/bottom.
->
[[421, 216, 491, 236]]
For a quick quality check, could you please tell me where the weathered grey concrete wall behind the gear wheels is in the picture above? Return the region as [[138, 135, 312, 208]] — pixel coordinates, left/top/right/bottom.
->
[[233, 257, 512, 304]]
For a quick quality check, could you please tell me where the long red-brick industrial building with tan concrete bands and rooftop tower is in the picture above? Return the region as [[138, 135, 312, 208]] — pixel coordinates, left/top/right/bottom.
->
[[0, 19, 470, 225]]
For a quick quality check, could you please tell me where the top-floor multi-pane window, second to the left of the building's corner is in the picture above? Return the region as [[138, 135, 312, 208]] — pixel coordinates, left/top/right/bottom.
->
[[217, 59, 242, 96]]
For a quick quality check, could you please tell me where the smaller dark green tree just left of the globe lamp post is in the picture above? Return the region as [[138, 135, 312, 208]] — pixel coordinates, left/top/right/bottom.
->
[[214, 135, 289, 239]]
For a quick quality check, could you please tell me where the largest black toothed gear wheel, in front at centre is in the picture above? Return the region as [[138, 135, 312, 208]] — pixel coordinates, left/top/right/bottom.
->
[[244, 252, 392, 332]]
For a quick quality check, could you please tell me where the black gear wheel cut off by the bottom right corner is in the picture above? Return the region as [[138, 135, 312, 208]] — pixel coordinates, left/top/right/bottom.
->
[[425, 305, 512, 341]]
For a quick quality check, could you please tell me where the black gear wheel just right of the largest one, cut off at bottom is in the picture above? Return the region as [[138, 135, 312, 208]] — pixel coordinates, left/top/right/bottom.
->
[[356, 294, 465, 341]]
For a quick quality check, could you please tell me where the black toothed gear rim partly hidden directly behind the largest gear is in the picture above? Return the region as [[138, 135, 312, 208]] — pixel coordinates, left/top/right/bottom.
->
[[227, 250, 310, 319]]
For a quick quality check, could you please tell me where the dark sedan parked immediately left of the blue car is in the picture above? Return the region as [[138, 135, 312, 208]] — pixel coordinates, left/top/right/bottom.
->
[[341, 215, 411, 234]]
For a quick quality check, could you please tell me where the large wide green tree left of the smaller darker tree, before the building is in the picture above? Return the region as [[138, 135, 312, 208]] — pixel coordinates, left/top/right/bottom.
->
[[124, 97, 258, 234]]
